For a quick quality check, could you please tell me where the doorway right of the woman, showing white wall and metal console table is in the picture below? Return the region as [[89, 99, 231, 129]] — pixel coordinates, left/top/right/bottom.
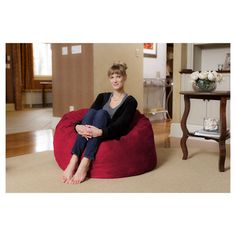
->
[[143, 43, 174, 121]]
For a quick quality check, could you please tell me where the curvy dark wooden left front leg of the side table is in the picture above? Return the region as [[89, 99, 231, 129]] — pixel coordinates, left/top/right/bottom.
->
[[180, 96, 190, 160]]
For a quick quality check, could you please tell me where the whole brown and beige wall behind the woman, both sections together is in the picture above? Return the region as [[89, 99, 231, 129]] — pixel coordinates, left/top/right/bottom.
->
[[52, 43, 143, 116]]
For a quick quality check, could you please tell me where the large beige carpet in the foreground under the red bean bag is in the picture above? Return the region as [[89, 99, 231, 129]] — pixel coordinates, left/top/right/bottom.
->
[[6, 148, 230, 193]]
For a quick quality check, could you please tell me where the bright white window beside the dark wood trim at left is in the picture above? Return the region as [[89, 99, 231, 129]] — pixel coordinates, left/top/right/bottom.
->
[[33, 43, 52, 79]]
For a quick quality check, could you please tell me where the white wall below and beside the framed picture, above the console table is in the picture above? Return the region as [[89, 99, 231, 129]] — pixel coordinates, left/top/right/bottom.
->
[[143, 43, 167, 78]]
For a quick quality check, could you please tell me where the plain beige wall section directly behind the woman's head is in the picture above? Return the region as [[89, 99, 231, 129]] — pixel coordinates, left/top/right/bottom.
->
[[93, 43, 143, 112]]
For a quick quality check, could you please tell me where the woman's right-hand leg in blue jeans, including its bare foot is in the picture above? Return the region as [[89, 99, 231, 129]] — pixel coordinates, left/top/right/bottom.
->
[[70, 110, 110, 184]]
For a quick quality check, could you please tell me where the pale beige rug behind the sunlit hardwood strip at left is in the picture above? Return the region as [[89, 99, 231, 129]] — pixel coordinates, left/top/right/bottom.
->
[[6, 108, 53, 134]]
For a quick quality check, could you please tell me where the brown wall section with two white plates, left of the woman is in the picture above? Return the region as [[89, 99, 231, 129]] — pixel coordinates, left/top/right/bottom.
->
[[52, 43, 93, 117]]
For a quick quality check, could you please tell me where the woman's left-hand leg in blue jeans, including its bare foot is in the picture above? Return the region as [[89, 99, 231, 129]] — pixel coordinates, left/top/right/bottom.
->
[[62, 109, 97, 183]]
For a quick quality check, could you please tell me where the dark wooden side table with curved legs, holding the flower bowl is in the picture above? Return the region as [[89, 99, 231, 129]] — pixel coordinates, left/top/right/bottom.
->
[[180, 91, 230, 172]]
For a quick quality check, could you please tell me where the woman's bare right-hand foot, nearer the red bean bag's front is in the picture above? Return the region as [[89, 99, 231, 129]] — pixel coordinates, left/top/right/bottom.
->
[[69, 157, 91, 184]]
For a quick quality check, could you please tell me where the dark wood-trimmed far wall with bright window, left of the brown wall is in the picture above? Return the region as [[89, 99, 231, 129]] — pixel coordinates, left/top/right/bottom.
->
[[6, 43, 52, 111]]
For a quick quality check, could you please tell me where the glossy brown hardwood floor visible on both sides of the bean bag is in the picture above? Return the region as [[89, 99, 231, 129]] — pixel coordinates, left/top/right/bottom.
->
[[6, 121, 170, 158]]
